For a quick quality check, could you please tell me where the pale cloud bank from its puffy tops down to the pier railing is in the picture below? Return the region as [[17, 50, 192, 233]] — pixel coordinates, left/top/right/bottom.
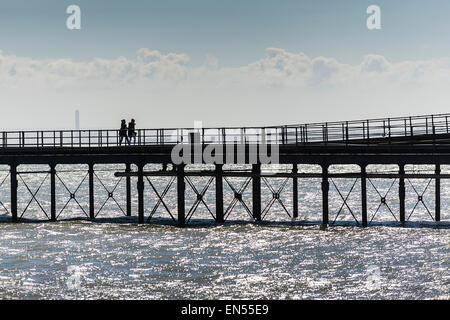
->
[[0, 48, 450, 127]]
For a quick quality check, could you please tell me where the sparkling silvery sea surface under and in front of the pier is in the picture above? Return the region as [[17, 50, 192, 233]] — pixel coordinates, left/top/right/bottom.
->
[[0, 166, 450, 299]]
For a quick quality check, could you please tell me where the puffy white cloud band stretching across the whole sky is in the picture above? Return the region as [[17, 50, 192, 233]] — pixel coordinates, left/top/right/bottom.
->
[[0, 48, 450, 88]]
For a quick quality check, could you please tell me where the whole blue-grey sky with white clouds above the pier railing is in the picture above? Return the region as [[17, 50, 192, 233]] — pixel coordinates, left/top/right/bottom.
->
[[0, 0, 450, 130]]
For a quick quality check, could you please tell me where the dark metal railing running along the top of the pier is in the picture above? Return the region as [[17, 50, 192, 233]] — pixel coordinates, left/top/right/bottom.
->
[[0, 114, 450, 148]]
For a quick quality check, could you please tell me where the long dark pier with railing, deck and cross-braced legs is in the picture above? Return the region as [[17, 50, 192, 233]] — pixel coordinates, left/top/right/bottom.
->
[[0, 114, 450, 227]]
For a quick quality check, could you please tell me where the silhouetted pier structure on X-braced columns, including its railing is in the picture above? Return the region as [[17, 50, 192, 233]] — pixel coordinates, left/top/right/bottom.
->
[[0, 114, 450, 227]]
